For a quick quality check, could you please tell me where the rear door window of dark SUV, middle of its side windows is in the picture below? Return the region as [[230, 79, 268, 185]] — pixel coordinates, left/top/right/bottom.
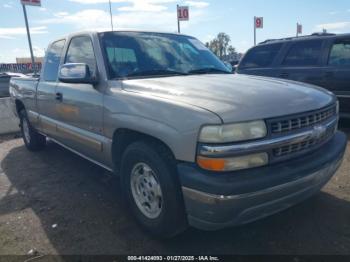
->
[[283, 40, 323, 66]]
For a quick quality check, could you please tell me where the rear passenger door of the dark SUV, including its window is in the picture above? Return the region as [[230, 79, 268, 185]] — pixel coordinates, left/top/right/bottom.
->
[[277, 39, 324, 86]]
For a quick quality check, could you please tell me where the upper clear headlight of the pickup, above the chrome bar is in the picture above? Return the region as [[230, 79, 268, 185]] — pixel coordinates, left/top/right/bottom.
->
[[199, 120, 267, 143]]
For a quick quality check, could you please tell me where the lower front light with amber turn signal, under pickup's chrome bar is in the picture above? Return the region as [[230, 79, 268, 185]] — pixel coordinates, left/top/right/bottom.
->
[[197, 153, 269, 171]]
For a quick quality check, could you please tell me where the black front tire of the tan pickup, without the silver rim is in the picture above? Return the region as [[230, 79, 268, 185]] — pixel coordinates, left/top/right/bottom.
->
[[121, 141, 187, 238]]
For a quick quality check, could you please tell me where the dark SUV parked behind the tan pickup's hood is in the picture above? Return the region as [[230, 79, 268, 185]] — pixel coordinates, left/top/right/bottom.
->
[[237, 33, 350, 118]]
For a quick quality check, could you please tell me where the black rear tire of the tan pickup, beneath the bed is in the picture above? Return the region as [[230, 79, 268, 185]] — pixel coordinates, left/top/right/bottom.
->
[[19, 110, 46, 151]]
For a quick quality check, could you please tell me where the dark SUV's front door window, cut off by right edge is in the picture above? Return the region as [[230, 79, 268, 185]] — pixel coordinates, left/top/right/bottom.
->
[[328, 39, 350, 66]]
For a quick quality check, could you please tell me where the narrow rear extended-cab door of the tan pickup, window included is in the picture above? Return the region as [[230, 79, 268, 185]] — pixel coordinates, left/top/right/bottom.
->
[[37, 40, 65, 138]]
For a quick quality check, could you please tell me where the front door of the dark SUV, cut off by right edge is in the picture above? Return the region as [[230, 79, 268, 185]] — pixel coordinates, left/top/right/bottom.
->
[[324, 37, 350, 118]]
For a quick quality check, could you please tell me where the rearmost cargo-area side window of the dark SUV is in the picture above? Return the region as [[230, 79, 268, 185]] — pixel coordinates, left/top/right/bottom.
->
[[240, 44, 282, 68]]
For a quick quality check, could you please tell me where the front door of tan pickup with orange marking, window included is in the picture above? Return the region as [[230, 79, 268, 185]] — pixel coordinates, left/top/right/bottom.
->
[[56, 35, 103, 160]]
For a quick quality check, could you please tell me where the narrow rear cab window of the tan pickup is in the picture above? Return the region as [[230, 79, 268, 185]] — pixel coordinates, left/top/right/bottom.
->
[[43, 40, 66, 82]]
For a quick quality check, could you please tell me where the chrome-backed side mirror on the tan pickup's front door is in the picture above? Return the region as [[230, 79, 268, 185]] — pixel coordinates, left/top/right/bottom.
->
[[58, 63, 97, 84]]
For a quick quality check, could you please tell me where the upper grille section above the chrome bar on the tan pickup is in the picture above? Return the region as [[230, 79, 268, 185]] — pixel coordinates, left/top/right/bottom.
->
[[270, 106, 336, 134]]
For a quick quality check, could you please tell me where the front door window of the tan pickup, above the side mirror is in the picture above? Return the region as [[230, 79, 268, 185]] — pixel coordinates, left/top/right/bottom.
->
[[65, 36, 96, 75]]
